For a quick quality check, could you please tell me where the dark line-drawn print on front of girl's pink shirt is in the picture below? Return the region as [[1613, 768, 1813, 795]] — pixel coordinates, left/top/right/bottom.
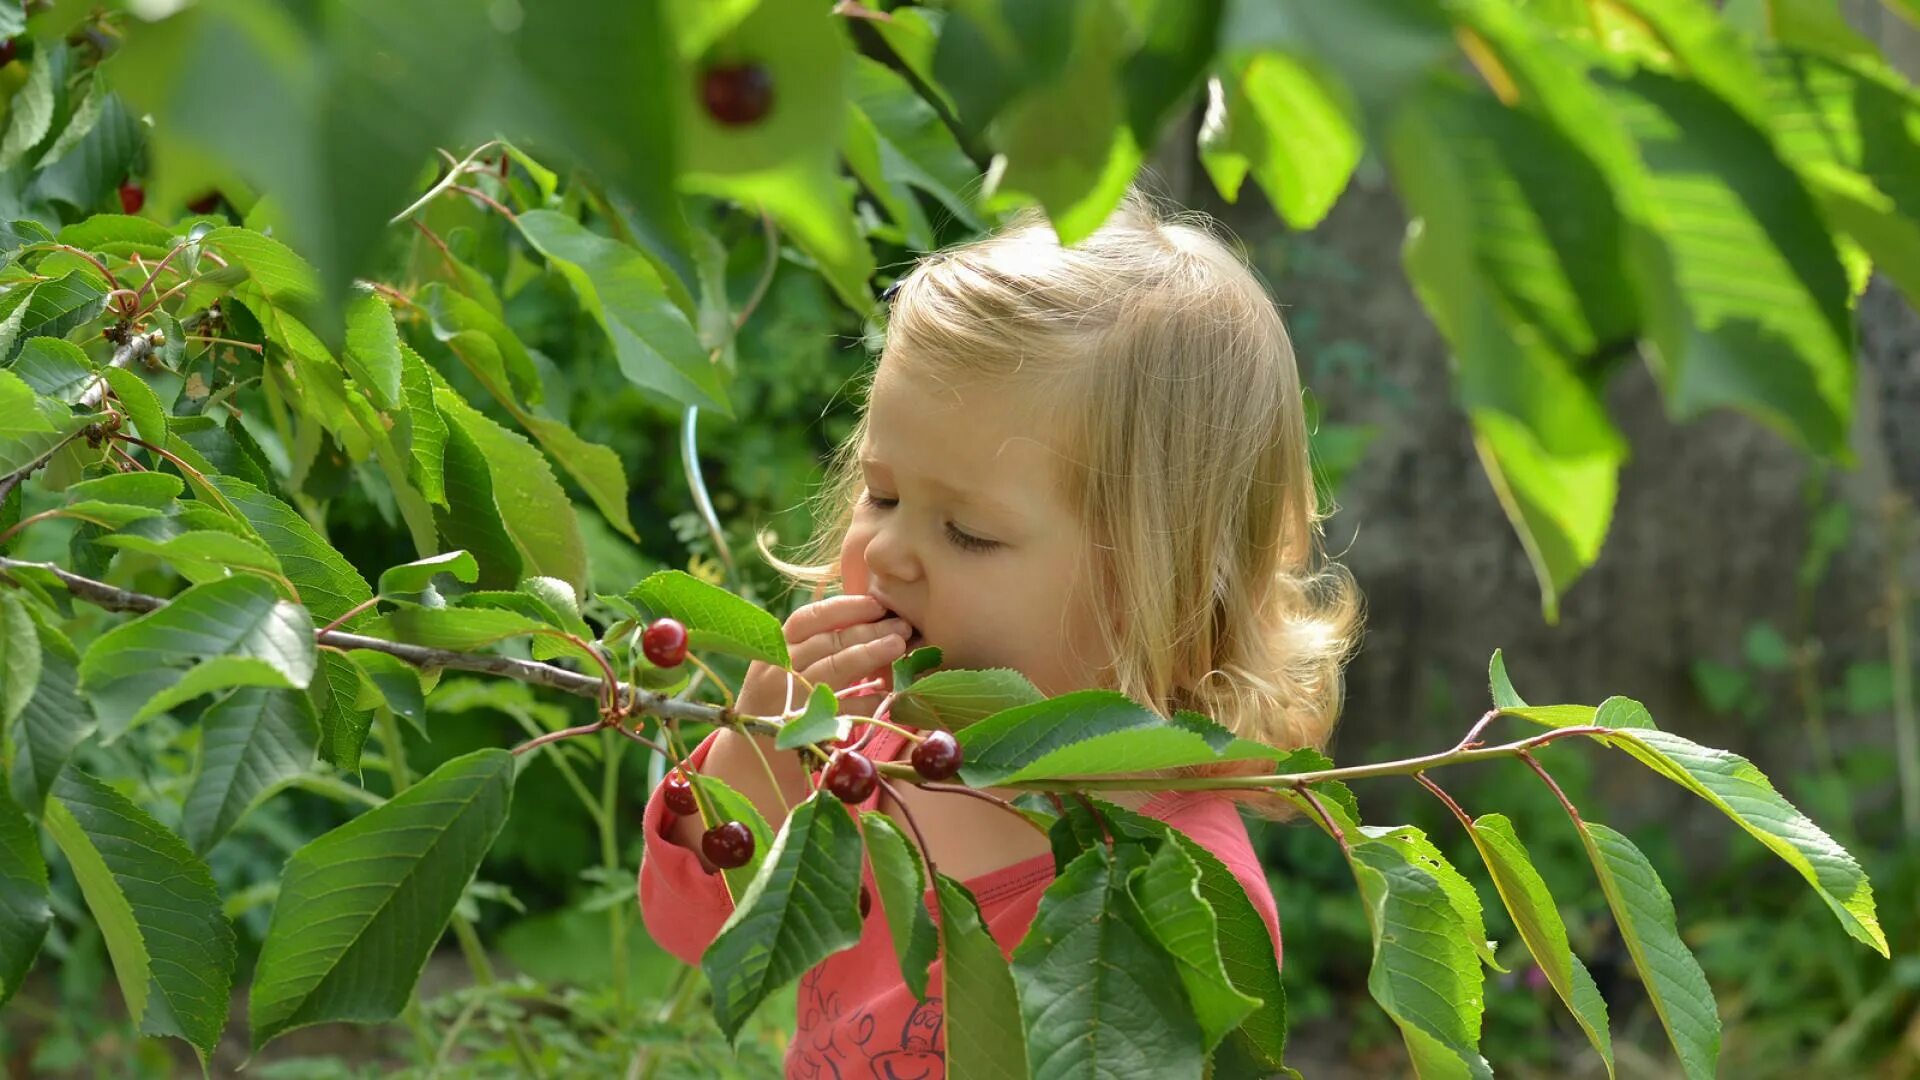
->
[[787, 965, 947, 1080]]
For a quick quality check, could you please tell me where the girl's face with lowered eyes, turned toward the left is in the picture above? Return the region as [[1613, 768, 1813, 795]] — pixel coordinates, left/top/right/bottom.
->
[[841, 363, 1106, 694]]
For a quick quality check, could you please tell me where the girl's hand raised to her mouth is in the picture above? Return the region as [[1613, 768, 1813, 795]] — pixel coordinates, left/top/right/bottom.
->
[[733, 596, 914, 717]]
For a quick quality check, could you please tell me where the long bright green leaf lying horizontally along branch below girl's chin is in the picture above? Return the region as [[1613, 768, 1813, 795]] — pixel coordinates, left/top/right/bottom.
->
[[958, 690, 1281, 788]]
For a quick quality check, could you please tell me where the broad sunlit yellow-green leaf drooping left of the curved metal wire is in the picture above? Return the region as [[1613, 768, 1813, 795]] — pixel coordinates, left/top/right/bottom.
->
[[434, 388, 588, 592]]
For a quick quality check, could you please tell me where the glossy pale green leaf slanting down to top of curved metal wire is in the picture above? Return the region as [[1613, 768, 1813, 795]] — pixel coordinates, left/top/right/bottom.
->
[[516, 209, 732, 415]]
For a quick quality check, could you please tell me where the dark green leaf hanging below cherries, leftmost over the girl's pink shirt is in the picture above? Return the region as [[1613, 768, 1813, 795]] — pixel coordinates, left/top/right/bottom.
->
[[701, 792, 860, 1040]]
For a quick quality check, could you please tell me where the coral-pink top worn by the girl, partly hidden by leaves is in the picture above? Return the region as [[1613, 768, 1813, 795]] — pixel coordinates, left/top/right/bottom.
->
[[639, 718, 1281, 1080]]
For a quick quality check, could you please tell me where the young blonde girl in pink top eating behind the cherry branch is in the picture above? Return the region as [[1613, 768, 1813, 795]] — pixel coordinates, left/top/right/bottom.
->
[[639, 184, 1359, 1078]]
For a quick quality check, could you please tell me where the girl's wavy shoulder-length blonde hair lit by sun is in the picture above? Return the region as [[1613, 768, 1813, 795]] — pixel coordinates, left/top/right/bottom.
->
[[762, 188, 1361, 813]]
